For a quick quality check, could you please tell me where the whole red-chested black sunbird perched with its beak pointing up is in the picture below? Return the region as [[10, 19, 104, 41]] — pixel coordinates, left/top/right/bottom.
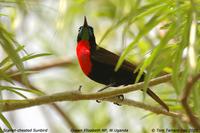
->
[[76, 17, 169, 111]]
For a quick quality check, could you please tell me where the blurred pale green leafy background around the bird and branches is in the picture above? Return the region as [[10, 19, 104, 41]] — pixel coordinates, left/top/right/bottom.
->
[[0, 0, 200, 133]]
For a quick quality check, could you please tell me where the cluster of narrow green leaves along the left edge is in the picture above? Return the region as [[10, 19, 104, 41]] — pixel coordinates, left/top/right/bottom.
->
[[0, 1, 48, 130]]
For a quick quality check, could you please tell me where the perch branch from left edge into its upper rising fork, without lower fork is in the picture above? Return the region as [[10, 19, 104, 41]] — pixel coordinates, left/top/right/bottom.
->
[[0, 75, 171, 111]]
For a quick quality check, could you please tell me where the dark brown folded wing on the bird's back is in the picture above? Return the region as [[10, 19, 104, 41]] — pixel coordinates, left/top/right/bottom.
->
[[91, 47, 136, 71]]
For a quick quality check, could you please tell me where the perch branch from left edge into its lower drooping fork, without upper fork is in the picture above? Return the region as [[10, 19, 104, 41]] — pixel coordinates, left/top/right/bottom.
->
[[0, 91, 182, 118]]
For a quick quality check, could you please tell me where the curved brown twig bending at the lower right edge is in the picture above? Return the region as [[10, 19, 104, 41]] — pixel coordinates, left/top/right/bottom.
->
[[181, 74, 200, 129]]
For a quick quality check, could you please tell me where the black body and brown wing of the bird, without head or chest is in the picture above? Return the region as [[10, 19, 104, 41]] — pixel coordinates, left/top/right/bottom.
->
[[88, 47, 140, 87]]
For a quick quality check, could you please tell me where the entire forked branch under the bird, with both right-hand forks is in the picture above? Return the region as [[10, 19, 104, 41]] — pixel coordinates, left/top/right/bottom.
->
[[0, 72, 182, 121]]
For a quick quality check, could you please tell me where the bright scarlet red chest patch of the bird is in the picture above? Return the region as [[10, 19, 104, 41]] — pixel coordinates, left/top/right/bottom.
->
[[76, 40, 92, 75]]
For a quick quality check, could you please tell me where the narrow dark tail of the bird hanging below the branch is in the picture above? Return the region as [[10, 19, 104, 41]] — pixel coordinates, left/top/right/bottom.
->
[[147, 88, 169, 111]]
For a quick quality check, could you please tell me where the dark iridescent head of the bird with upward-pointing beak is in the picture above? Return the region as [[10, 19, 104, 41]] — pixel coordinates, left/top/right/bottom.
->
[[77, 17, 96, 45]]
